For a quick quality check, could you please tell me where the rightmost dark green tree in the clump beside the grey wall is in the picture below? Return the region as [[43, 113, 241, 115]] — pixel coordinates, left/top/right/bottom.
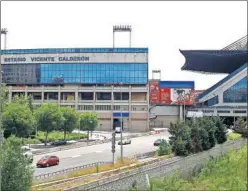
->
[[214, 117, 227, 144]]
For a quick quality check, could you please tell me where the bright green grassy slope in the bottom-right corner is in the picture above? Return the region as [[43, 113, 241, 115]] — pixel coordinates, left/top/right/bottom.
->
[[147, 146, 247, 191]]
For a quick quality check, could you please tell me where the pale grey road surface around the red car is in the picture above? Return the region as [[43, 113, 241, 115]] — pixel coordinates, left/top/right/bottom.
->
[[34, 131, 169, 176]]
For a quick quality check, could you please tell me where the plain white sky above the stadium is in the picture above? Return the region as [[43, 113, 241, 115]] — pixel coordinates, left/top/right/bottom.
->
[[1, 1, 247, 90]]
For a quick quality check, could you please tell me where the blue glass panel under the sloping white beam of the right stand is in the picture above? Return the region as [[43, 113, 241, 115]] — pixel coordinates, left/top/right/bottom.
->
[[223, 76, 247, 103]]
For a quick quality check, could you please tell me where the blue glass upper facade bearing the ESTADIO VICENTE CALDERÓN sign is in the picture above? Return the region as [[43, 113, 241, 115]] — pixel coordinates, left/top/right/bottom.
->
[[1, 48, 148, 84]]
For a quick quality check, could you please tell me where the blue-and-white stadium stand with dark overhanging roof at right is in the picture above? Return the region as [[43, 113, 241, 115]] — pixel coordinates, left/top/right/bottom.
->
[[181, 36, 248, 121]]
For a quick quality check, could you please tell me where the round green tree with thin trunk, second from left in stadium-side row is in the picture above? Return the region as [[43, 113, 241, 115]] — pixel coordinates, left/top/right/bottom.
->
[[35, 104, 64, 145]]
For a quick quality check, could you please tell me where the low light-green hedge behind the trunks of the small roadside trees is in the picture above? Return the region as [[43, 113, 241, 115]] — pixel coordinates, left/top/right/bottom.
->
[[37, 131, 87, 143]]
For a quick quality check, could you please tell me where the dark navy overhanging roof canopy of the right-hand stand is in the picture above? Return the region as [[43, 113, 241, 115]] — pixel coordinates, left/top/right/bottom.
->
[[180, 50, 248, 74]]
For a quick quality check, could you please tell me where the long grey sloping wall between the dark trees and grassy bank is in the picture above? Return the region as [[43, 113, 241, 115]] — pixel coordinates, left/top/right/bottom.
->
[[67, 139, 247, 191]]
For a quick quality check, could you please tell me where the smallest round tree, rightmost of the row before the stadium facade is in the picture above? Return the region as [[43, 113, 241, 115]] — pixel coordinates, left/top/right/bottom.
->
[[79, 112, 98, 140]]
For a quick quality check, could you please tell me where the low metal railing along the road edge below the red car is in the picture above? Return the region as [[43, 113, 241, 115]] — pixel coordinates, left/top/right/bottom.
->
[[33, 162, 112, 180]]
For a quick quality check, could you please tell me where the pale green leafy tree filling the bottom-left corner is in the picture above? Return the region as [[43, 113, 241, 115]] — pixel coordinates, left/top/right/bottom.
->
[[0, 137, 34, 191]]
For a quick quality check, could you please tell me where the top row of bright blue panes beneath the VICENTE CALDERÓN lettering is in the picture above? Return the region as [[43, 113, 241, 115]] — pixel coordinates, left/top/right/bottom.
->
[[40, 63, 148, 71]]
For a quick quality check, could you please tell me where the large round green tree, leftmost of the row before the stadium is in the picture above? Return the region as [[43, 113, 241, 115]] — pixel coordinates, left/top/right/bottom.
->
[[2, 103, 35, 137]]
